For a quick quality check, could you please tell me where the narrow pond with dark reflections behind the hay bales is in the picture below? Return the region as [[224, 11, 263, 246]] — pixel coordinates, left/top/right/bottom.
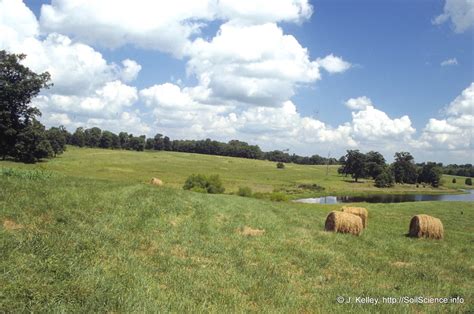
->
[[294, 190, 474, 204]]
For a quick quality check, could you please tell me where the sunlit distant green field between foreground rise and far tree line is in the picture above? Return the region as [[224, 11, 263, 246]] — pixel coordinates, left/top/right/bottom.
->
[[0, 147, 465, 197]]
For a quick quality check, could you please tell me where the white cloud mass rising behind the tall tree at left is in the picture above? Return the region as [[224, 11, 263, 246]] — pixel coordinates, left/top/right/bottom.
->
[[0, 0, 148, 129]]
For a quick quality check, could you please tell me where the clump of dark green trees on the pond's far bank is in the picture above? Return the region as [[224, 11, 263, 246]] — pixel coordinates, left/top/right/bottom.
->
[[338, 150, 442, 188]]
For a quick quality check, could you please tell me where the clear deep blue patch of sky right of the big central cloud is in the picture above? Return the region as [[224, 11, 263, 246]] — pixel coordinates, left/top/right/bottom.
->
[[288, 0, 473, 127]]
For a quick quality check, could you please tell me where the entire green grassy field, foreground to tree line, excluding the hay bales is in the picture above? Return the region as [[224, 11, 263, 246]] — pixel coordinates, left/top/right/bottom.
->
[[0, 149, 474, 313]]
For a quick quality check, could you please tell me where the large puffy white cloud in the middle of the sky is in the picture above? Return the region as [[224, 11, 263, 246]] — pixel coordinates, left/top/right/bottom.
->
[[188, 23, 332, 106]]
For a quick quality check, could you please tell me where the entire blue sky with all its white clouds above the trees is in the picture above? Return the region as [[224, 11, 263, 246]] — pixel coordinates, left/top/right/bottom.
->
[[0, 0, 474, 162]]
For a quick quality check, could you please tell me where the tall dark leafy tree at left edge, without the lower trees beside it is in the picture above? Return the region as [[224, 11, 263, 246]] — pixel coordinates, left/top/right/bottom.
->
[[0, 50, 51, 159]]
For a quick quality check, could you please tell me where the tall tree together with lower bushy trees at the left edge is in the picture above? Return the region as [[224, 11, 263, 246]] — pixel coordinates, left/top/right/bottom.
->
[[0, 50, 67, 163]]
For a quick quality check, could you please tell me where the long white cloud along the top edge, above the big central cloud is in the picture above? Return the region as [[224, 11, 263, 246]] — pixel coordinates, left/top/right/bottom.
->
[[41, 0, 312, 56]]
